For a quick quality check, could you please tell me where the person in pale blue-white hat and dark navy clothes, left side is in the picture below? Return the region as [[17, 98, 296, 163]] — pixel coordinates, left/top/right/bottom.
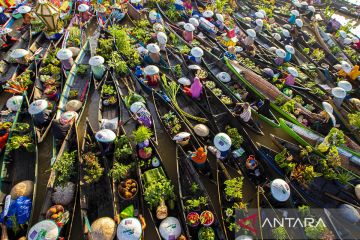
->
[[28, 99, 51, 128]]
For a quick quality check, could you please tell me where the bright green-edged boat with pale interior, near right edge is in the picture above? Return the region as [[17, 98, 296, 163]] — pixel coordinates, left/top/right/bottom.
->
[[280, 119, 360, 165]]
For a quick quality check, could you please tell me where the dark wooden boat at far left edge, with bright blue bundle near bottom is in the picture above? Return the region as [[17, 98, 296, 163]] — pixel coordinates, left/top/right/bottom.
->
[[0, 95, 38, 239]]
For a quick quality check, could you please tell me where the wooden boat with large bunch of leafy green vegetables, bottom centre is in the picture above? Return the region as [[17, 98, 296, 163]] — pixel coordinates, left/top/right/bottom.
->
[[140, 141, 190, 239]]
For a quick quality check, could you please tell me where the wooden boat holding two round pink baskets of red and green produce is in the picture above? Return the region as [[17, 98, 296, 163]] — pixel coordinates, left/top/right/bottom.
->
[[176, 147, 226, 240]]
